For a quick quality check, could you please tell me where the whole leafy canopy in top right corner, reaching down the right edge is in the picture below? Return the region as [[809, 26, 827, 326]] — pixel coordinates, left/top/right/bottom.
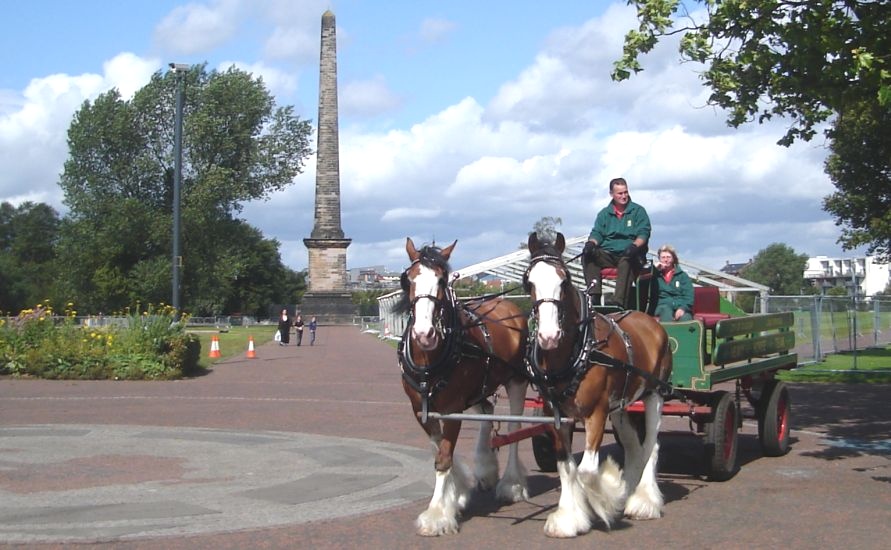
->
[[613, 0, 891, 259]]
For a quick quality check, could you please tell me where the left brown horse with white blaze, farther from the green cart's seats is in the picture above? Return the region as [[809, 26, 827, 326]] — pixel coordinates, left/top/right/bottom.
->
[[397, 238, 529, 536]]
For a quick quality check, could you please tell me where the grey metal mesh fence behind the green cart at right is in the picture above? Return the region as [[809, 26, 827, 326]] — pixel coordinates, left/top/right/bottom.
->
[[756, 296, 891, 362]]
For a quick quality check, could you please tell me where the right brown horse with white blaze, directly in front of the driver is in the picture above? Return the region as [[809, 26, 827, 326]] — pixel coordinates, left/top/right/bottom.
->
[[524, 233, 672, 537]]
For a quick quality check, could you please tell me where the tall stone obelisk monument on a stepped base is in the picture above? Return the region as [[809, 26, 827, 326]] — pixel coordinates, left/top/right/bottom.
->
[[300, 10, 356, 324]]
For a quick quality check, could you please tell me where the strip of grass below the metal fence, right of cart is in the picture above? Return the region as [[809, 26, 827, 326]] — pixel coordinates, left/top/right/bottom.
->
[[779, 346, 891, 384]]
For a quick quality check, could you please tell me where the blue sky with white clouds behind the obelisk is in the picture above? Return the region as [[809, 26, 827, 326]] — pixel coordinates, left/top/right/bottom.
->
[[0, 0, 862, 276]]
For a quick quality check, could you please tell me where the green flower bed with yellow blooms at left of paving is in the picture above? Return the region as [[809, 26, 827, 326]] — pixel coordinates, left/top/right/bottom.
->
[[0, 303, 200, 380]]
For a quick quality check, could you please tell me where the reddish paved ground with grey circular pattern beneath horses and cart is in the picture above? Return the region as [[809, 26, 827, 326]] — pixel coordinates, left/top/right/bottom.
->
[[0, 327, 891, 549]]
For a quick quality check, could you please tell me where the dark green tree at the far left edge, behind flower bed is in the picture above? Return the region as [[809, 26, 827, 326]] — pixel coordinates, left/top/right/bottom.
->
[[0, 202, 59, 313]]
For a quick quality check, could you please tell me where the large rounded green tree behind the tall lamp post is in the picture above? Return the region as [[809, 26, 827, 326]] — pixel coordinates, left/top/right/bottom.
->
[[59, 65, 311, 315]]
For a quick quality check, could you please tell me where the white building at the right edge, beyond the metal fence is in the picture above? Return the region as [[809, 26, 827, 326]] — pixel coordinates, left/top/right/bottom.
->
[[804, 256, 891, 296]]
